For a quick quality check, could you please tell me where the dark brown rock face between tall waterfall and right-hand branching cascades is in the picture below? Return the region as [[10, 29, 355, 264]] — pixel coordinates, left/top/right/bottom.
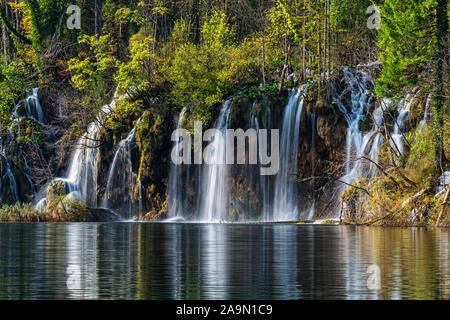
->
[[298, 97, 347, 218]]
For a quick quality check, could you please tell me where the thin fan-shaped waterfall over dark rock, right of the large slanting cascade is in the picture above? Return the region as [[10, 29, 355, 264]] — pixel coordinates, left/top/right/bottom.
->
[[103, 113, 145, 218]]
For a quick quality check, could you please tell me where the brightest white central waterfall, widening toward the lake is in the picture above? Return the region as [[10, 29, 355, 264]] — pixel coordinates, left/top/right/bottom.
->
[[199, 99, 231, 222]]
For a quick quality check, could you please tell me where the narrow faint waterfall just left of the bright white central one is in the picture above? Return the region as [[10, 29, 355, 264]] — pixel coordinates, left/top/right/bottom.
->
[[168, 107, 187, 218]]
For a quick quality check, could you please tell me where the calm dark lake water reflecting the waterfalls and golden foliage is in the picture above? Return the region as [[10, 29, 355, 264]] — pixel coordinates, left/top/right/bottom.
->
[[0, 223, 450, 299]]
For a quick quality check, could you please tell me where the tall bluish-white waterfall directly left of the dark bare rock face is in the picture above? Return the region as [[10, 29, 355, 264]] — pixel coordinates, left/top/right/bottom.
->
[[272, 85, 307, 221]]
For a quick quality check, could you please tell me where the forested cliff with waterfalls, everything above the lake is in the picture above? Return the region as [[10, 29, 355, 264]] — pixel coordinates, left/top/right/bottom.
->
[[0, 0, 450, 226]]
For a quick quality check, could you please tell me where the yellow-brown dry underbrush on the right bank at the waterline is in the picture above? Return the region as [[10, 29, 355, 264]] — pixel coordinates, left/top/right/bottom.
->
[[341, 126, 450, 226]]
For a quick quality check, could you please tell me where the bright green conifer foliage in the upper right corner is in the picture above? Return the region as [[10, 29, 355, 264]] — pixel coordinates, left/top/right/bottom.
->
[[376, 0, 436, 97]]
